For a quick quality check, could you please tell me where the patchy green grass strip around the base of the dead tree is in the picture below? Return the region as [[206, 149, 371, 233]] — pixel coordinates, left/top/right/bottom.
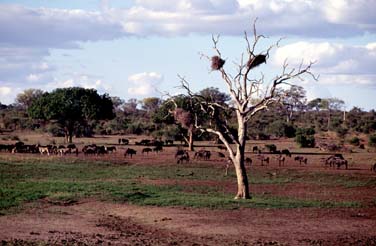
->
[[0, 155, 376, 214]]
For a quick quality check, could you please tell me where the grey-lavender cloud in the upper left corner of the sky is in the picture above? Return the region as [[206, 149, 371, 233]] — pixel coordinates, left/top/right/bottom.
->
[[0, 4, 124, 48]]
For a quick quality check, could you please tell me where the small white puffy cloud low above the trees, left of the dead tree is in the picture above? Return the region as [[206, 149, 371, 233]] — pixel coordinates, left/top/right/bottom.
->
[[128, 72, 163, 96]]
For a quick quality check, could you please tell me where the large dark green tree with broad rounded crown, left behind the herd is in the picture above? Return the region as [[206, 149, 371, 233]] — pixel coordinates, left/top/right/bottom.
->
[[28, 87, 115, 143]]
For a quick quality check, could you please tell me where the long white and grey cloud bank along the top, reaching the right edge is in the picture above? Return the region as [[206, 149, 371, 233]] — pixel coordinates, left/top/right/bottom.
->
[[100, 0, 376, 37]]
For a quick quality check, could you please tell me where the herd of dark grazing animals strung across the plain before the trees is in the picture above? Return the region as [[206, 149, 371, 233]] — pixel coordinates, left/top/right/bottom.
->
[[0, 138, 376, 173]]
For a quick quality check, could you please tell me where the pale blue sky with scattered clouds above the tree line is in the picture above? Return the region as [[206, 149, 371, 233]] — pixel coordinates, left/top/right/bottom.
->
[[0, 0, 376, 110]]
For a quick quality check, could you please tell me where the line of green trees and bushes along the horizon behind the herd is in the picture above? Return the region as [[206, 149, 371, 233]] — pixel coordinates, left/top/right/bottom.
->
[[0, 86, 376, 144]]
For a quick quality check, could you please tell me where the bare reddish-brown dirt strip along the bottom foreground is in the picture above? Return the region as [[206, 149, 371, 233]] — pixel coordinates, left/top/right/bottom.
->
[[0, 201, 376, 245]]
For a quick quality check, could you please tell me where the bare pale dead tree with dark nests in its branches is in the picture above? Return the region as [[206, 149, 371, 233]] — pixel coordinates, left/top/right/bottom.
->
[[179, 22, 316, 199]]
